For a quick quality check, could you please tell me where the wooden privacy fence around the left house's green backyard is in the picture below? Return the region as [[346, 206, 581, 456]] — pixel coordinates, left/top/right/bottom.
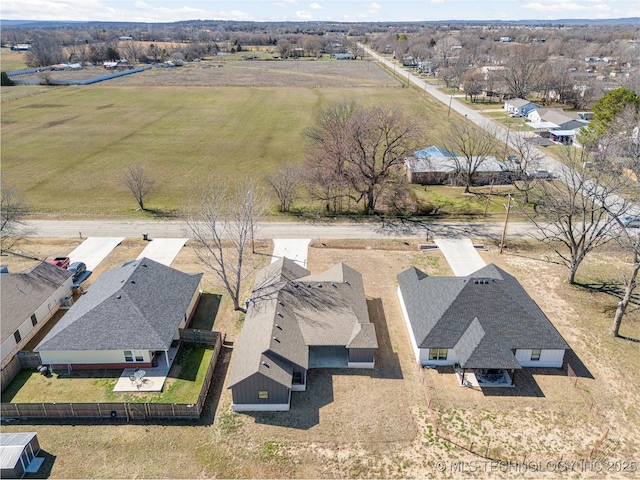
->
[[1, 332, 222, 421]]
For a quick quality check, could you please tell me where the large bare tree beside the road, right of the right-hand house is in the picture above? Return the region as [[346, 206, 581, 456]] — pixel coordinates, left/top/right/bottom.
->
[[525, 147, 630, 284]]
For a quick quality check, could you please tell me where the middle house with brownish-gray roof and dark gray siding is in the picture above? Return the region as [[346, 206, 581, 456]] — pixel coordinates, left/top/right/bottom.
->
[[227, 257, 378, 411]]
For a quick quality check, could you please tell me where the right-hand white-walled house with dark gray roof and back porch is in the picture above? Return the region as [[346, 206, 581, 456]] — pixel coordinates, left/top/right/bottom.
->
[[397, 264, 569, 386]]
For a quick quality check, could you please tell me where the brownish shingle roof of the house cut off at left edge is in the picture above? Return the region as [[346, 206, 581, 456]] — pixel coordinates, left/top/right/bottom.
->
[[0, 262, 71, 342]]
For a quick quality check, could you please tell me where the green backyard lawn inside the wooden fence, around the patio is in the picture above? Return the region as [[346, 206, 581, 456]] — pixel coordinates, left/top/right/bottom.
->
[[2, 345, 213, 404]]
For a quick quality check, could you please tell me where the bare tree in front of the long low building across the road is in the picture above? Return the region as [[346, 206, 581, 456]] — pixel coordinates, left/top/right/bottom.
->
[[441, 120, 498, 193]]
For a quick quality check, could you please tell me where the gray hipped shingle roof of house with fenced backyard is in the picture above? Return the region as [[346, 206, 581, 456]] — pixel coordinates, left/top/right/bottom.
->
[[35, 258, 202, 351]]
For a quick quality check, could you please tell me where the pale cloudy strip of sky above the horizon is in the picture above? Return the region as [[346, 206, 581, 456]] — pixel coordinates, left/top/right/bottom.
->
[[0, 0, 640, 22]]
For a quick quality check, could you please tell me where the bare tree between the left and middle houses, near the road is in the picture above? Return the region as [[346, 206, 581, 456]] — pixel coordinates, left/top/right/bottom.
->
[[185, 179, 265, 312]]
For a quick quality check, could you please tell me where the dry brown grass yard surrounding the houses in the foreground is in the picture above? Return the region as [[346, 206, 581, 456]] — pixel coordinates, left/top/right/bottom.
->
[[3, 236, 640, 478]]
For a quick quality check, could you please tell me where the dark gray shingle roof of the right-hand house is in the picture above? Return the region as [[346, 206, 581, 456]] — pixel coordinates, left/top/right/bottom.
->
[[398, 264, 568, 368]]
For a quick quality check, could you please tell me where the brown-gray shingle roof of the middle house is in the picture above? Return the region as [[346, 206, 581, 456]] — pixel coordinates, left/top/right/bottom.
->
[[228, 257, 378, 388]]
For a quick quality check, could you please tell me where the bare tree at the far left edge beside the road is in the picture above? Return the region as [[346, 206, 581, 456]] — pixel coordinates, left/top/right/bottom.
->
[[0, 183, 32, 253]]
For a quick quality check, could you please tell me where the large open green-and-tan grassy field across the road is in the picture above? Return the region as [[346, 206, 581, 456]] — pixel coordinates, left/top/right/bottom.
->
[[1, 61, 462, 216]]
